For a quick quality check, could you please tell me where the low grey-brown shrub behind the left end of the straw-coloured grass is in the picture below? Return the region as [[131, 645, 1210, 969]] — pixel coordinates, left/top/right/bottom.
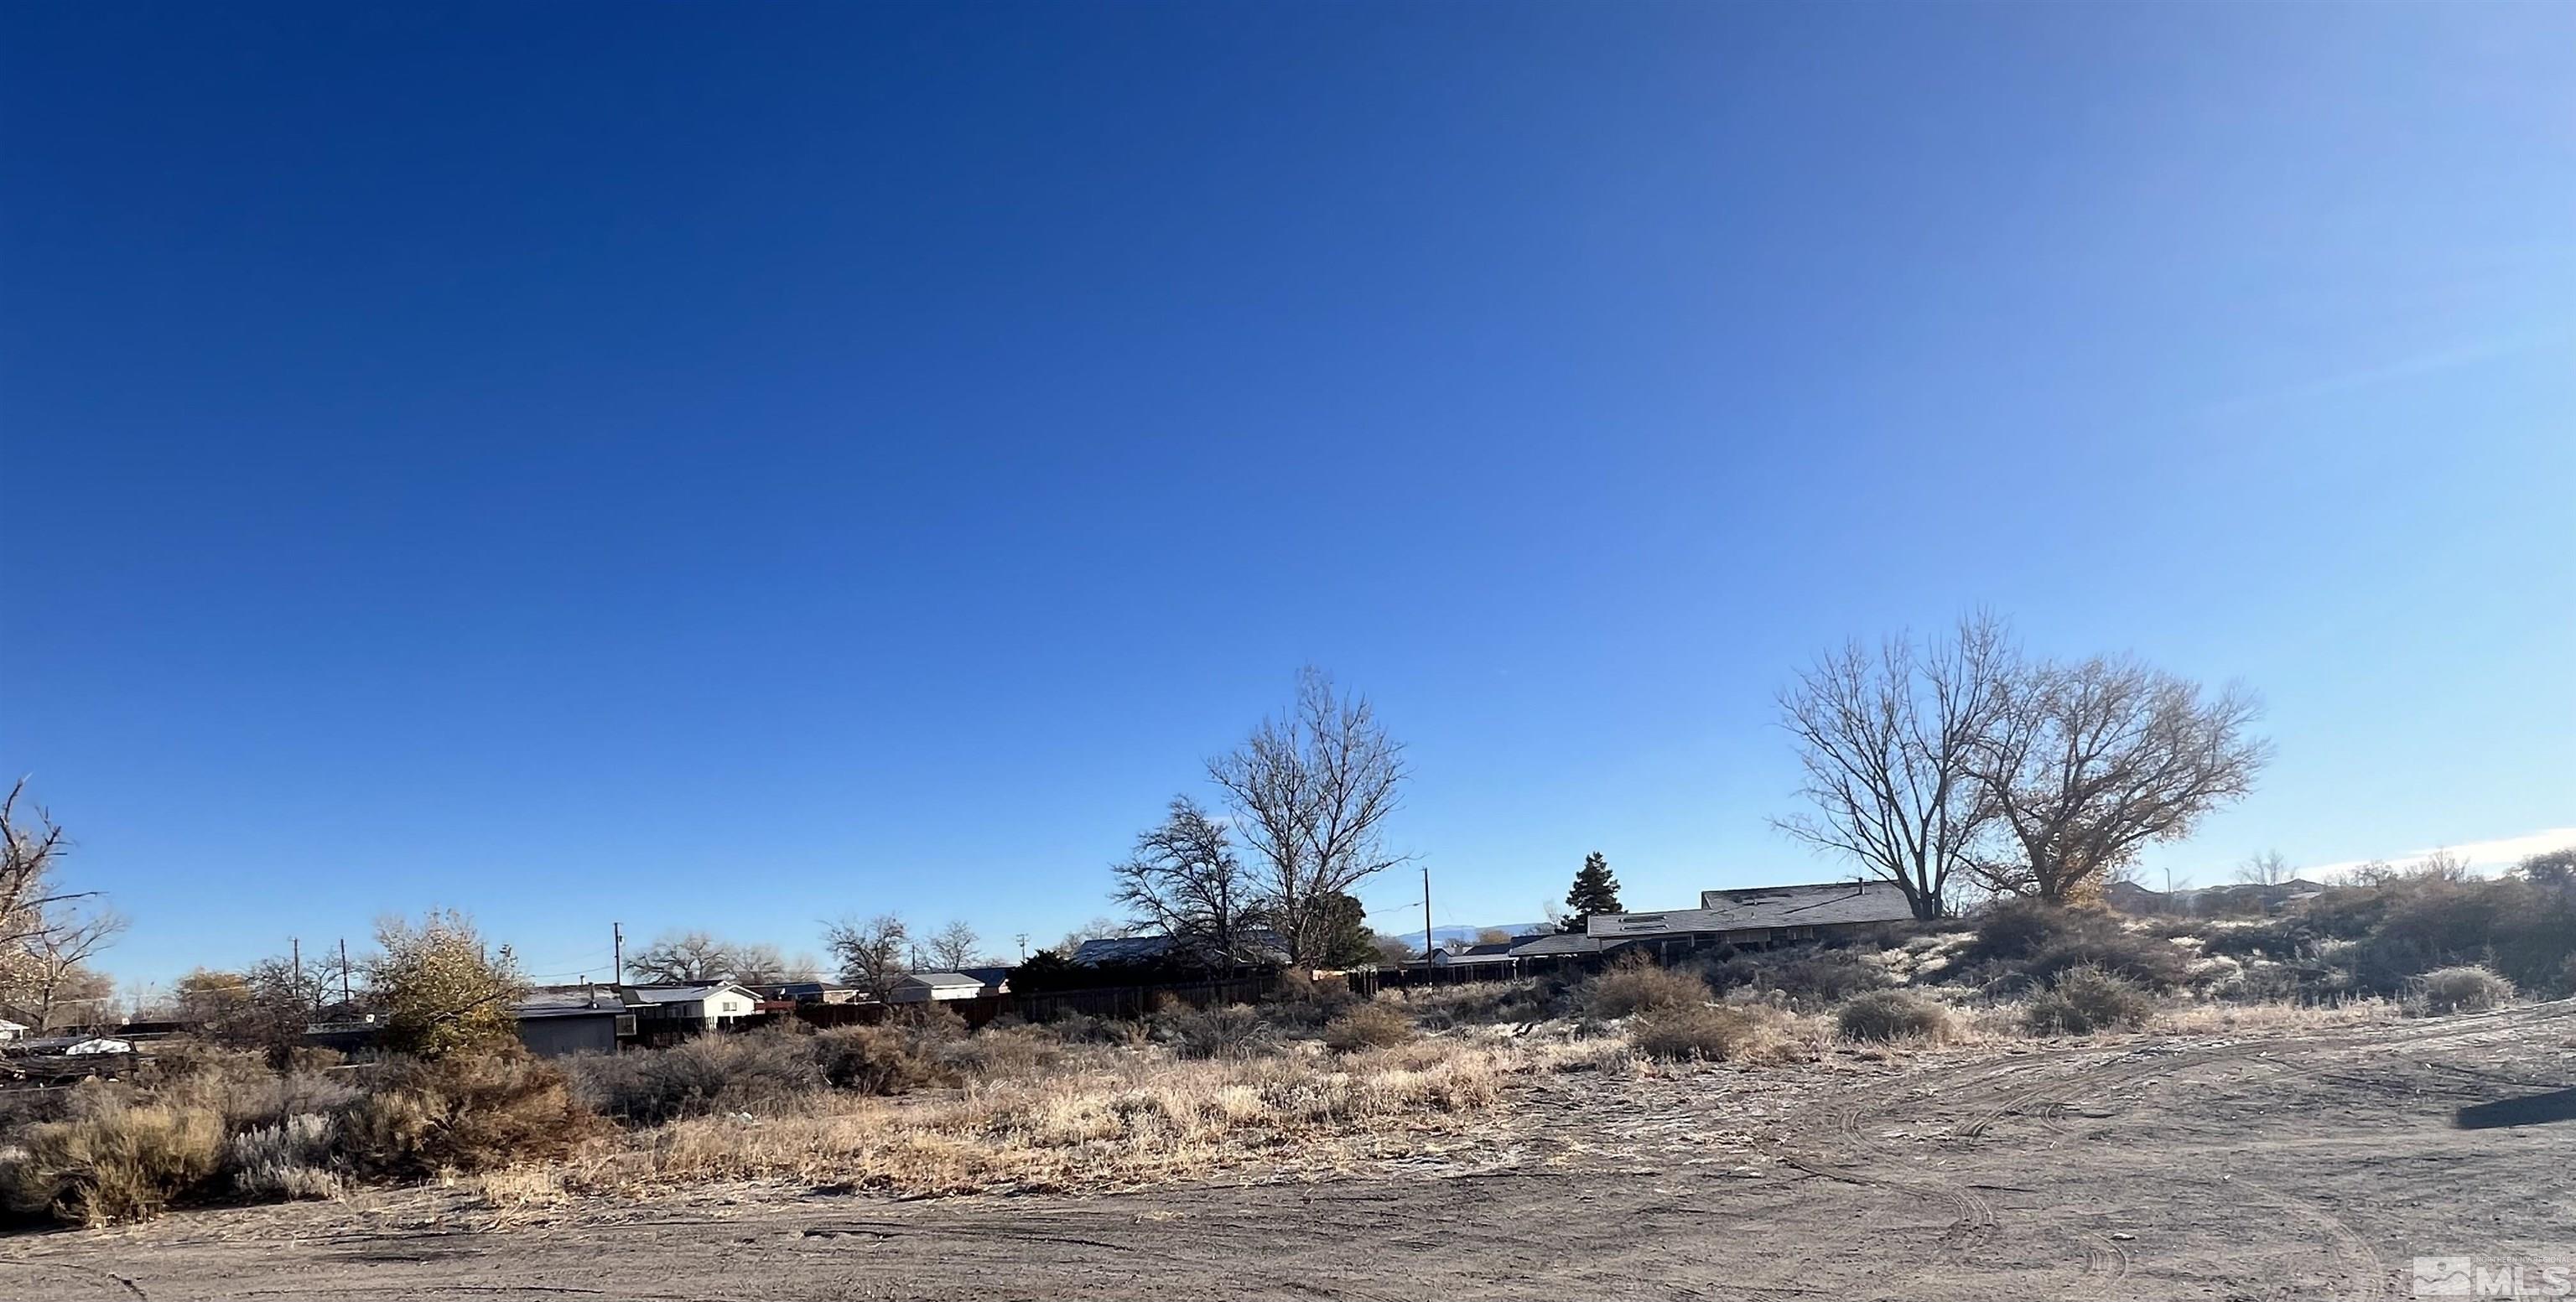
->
[[564, 1032, 824, 1124]]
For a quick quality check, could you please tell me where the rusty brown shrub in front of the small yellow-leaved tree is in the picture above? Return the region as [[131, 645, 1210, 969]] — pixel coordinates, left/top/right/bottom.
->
[[340, 1052, 600, 1179]]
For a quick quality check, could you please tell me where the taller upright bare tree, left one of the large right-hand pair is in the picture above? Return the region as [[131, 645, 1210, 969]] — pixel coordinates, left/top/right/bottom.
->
[[1773, 615, 2012, 919]]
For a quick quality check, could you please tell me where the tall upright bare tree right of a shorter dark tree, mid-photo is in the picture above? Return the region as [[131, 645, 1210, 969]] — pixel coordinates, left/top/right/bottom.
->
[[1208, 667, 1404, 965]]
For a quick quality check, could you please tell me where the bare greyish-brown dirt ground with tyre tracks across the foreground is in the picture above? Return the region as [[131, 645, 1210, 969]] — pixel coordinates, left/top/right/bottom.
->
[[0, 1001, 2576, 1302]]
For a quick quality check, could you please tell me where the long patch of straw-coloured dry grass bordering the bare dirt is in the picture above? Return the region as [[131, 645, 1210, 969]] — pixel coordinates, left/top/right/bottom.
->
[[567, 1040, 1543, 1194]]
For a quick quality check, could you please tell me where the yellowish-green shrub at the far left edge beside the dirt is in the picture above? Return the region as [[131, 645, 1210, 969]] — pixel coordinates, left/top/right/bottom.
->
[[0, 1081, 224, 1225]]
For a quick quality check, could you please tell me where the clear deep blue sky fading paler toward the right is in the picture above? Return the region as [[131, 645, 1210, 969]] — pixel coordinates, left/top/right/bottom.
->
[[0, 3, 2576, 980]]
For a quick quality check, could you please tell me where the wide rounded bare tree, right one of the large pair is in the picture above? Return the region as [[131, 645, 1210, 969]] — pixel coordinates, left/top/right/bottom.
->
[[1973, 656, 2269, 900]]
